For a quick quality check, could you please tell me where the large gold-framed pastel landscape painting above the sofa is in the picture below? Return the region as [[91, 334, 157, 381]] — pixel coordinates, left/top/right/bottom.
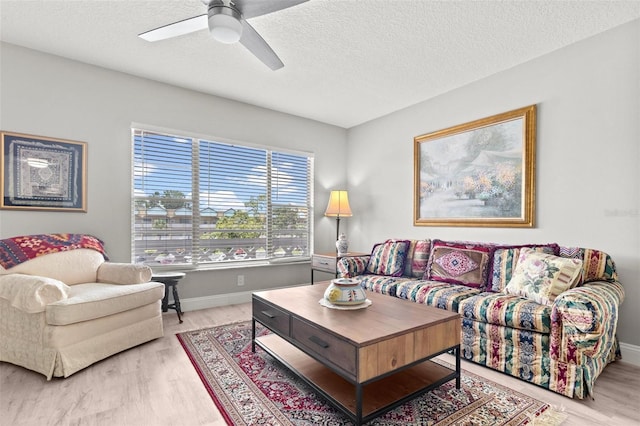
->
[[414, 105, 536, 227]]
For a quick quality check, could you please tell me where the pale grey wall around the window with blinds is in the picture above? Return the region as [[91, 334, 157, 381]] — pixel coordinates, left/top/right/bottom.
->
[[0, 43, 346, 299]]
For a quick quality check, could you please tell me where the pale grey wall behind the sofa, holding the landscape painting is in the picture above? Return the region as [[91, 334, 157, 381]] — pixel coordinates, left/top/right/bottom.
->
[[348, 21, 640, 345]]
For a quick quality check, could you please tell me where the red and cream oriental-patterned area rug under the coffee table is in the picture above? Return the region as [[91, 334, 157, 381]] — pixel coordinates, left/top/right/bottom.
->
[[177, 321, 564, 426]]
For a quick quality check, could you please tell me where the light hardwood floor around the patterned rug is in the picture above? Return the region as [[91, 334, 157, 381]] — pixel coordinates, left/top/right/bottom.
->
[[0, 304, 640, 426]]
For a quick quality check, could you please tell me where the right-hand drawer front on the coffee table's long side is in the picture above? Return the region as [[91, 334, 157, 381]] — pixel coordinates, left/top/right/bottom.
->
[[291, 317, 356, 377]]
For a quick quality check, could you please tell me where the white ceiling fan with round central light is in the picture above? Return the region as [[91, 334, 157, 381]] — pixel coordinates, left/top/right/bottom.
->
[[138, 0, 308, 70]]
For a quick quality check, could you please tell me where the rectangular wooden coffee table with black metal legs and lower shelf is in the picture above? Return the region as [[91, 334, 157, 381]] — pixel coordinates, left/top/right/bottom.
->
[[252, 281, 461, 425]]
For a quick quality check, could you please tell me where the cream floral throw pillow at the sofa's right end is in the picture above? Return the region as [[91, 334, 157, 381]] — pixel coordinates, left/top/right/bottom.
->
[[505, 248, 582, 305]]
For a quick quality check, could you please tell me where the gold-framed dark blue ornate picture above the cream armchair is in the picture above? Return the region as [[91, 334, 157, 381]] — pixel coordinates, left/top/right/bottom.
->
[[0, 131, 87, 212]]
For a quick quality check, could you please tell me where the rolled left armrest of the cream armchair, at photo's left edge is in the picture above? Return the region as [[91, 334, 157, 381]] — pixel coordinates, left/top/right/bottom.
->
[[0, 274, 69, 314]]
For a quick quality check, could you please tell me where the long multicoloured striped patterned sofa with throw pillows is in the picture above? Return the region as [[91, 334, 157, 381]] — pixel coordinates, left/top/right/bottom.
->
[[338, 239, 624, 399]]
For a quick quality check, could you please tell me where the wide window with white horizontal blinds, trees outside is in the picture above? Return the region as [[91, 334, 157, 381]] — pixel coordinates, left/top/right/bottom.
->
[[132, 129, 313, 267]]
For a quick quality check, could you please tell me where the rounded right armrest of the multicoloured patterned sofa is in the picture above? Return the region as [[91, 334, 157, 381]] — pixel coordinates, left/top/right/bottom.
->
[[550, 281, 624, 364]]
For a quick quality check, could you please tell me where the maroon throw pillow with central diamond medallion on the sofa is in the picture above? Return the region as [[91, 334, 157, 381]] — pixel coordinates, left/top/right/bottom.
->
[[425, 240, 493, 288]]
